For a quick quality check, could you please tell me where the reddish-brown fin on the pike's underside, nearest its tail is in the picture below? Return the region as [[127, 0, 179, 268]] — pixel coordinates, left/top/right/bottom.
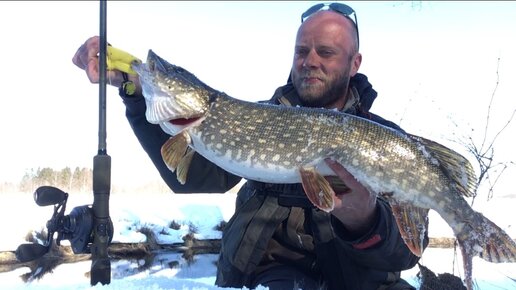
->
[[387, 198, 429, 257]]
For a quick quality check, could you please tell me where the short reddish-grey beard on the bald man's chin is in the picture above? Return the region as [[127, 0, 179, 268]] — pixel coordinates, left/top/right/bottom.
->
[[292, 65, 351, 108]]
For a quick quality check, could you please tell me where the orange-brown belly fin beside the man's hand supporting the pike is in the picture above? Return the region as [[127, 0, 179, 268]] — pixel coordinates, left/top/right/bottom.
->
[[299, 167, 335, 212]]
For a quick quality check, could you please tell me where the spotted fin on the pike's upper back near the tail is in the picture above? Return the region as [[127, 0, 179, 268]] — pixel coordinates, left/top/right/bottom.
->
[[408, 134, 477, 197]]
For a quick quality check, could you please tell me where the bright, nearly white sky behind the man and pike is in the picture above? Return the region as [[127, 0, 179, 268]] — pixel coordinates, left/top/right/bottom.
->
[[0, 1, 516, 199]]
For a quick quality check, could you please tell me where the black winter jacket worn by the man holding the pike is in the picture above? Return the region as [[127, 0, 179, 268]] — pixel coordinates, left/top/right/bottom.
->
[[123, 74, 428, 290]]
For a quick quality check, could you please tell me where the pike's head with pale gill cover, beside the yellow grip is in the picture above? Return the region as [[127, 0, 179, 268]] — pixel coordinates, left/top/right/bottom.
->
[[132, 50, 216, 134]]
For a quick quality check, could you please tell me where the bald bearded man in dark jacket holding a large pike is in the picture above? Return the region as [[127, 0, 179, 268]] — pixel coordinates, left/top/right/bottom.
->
[[73, 3, 427, 290]]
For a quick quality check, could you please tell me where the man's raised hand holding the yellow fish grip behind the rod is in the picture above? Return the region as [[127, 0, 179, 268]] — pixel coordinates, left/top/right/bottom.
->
[[72, 36, 141, 94]]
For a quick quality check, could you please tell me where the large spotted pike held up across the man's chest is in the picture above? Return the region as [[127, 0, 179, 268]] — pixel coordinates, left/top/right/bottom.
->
[[133, 50, 516, 289]]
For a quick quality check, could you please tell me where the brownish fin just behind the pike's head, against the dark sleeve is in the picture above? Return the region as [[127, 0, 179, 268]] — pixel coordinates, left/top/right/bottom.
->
[[161, 131, 191, 173]]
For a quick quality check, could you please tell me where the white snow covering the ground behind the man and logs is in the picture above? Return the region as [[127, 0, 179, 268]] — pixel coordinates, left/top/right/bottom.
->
[[0, 193, 516, 290]]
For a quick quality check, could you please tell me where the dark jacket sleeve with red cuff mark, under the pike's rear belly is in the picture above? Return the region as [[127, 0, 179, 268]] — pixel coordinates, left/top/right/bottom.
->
[[331, 197, 428, 271]]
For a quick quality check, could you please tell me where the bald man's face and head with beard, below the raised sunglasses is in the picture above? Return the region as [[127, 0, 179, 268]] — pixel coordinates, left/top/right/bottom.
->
[[292, 11, 361, 109]]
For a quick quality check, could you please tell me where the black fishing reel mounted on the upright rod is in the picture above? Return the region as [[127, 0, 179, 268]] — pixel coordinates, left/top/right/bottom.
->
[[15, 186, 113, 263]]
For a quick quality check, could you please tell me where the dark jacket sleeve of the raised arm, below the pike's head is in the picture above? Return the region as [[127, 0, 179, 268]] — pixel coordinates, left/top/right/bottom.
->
[[121, 96, 241, 193]]
